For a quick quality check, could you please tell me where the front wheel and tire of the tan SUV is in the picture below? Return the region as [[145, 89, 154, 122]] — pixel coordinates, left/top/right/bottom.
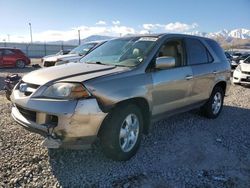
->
[[100, 104, 143, 161]]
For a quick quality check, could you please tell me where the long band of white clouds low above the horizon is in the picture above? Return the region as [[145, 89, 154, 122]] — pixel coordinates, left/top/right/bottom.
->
[[0, 20, 198, 42]]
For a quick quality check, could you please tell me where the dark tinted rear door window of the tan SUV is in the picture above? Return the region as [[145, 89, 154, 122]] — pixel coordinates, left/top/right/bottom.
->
[[186, 39, 213, 65]]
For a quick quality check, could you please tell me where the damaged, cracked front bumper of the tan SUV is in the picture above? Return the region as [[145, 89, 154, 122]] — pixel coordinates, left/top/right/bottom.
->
[[11, 90, 106, 149]]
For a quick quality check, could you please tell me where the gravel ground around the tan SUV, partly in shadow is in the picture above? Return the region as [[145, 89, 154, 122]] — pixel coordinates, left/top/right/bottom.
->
[[0, 68, 250, 188]]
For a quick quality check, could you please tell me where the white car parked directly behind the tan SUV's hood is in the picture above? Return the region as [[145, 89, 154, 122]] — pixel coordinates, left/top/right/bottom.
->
[[42, 41, 104, 67]]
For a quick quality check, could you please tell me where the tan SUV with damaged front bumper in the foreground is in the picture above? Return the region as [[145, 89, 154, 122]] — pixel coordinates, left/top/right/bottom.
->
[[11, 34, 231, 160]]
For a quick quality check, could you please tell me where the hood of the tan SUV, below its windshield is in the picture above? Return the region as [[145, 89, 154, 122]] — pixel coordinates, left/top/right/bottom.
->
[[22, 63, 128, 85]]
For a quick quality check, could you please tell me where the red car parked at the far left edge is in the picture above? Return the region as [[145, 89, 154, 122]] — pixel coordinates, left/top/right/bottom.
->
[[0, 48, 30, 68]]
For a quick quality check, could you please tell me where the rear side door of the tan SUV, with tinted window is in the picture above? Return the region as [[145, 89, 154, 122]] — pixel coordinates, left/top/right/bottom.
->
[[185, 38, 216, 103]]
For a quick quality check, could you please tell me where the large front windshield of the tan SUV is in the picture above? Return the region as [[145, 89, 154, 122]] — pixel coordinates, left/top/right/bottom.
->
[[81, 37, 158, 67]]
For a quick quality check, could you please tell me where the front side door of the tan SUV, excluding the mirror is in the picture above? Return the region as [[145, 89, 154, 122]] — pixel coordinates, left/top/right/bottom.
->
[[152, 38, 193, 116]]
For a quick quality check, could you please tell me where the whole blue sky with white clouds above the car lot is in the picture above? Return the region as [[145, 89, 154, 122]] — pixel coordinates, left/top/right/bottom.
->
[[0, 0, 250, 41]]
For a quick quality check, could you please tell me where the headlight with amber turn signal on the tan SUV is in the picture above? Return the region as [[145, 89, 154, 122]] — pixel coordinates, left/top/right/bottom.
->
[[42, 83, 90, 99]]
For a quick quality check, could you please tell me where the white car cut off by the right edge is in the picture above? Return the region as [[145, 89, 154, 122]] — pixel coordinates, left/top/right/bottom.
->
[[233, 56, 250, 84]]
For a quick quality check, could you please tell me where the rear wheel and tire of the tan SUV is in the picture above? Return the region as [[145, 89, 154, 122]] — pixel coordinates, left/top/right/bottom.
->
[[201, 86, 225, 119]]
